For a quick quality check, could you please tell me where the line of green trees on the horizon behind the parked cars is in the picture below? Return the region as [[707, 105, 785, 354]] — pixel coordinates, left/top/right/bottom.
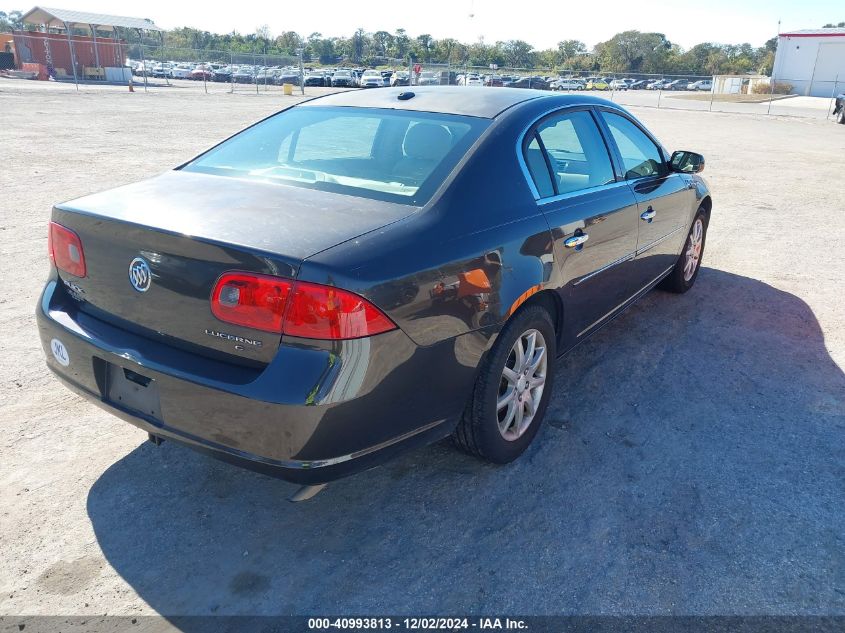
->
[[0, 11, 845, 75]]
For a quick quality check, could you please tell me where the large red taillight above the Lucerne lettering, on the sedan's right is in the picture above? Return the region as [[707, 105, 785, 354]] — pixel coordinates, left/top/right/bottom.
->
[[211, 272, 396, 340]]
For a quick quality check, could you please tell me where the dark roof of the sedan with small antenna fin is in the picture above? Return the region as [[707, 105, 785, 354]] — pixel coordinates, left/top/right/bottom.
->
[[297, 86, 607, 119]]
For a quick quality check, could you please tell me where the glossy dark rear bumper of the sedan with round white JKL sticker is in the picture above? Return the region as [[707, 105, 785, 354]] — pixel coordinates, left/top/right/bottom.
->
[[36, 279, 486, 484]]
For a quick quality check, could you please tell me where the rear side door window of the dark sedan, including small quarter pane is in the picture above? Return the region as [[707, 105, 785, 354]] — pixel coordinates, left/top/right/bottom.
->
[[525, 110, 615, 198]]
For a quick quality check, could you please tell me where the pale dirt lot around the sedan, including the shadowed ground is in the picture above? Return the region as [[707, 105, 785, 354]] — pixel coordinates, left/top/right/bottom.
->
[[0, 80, 845, 615]]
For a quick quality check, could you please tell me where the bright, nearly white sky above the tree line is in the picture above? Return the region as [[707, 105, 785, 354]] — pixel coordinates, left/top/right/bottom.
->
[[4, 0, 845, 49]]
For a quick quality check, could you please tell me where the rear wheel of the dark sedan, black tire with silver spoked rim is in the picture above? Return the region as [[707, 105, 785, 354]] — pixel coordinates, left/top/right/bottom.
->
[[452, 305, 557, 464]]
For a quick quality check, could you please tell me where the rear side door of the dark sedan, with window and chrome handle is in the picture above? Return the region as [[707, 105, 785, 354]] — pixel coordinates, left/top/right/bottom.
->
[[523, 107, 639, 351]]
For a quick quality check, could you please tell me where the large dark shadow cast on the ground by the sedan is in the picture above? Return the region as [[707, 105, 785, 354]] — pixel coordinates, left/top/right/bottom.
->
[[88, 269, 845, 615]]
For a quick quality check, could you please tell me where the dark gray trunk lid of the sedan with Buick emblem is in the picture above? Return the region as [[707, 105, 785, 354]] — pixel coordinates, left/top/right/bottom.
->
[[53, 171, 414, 363]]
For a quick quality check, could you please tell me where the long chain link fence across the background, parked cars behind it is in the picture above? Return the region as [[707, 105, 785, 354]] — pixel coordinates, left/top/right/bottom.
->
[[3, 31, 845, 118]]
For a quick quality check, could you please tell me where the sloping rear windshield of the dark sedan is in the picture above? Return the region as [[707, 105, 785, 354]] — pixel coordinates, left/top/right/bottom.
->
[[183, 106, 489, 206]]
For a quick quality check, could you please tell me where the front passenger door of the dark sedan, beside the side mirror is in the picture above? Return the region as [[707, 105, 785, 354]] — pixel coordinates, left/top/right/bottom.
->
[[601, 109, 695, 287]]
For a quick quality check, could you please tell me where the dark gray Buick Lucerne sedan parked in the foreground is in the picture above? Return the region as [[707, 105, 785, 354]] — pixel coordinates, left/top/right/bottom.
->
[[37, 87, 712, 484]]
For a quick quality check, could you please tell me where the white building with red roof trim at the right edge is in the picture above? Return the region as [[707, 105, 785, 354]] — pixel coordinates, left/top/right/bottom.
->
[[772, 28, 845, 97]]
